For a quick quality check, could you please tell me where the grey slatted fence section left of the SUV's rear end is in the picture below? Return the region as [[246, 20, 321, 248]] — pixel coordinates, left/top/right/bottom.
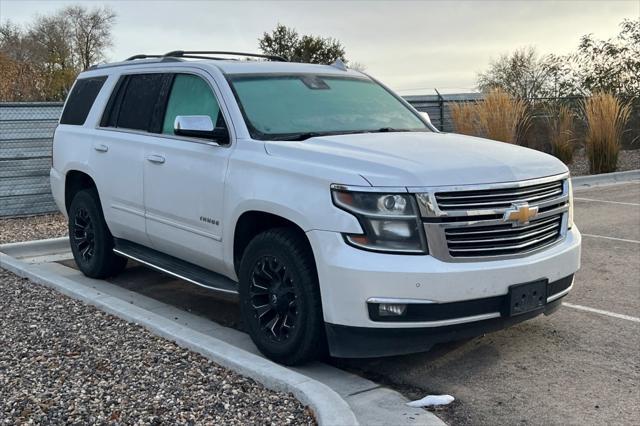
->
[[0, 102, 62, 217]]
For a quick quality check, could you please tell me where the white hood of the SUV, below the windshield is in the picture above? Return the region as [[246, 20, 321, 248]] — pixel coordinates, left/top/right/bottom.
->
[[265, 132, 567, 186]]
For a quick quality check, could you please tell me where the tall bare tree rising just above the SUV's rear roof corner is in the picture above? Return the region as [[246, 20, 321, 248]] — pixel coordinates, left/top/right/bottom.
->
[[63, 6, 116, 70]]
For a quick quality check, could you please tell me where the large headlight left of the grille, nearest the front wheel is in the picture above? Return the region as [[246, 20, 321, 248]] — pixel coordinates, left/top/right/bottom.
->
[[331, 186, 427, 254]]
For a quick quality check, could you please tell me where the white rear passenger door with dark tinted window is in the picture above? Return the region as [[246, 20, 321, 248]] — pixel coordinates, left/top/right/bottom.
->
[[90, 73, 168, 245]]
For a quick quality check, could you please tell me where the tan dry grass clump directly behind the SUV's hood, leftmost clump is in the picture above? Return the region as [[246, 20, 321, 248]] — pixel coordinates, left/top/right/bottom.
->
[[451, 89, 530, 144]]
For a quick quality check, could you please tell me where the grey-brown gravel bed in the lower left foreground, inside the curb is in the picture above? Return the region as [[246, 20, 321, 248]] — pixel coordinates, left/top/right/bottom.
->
[[0, 269, 315, 424]]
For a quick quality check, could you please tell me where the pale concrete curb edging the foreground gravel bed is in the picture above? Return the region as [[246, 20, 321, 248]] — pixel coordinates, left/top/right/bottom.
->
[[0, 250, 358, 426]]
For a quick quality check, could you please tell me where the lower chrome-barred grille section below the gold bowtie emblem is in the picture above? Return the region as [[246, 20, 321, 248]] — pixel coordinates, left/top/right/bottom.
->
[[444, 214, 562, 257]]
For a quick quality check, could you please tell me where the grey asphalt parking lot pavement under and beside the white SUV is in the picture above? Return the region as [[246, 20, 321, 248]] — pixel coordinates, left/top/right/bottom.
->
[[20, 183, 640, 424]]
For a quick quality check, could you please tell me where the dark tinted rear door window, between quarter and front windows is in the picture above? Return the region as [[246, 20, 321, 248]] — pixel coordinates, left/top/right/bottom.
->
[[116, 74, 165, 131]]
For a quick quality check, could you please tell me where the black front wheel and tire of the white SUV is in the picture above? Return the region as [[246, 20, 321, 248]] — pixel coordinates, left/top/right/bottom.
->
[[240, 228, 326, 365]]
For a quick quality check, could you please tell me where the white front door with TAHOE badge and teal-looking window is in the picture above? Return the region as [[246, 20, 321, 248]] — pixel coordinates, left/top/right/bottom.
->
[[144, 70, 231, 270]]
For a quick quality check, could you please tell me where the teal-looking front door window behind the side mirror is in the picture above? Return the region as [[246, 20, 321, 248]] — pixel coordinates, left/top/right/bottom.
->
[[162, 74, 225, 135]]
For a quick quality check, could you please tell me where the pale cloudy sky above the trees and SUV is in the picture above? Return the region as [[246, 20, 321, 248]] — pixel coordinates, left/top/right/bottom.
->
[[0, 0, 640, 95]]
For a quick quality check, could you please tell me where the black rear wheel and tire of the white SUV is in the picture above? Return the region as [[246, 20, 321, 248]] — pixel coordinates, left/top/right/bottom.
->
[[69, 189, 127, 279]]
